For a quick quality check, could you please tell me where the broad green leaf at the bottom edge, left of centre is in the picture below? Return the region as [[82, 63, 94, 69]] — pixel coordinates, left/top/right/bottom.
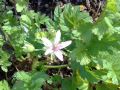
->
[[13, 71, 49, 90]]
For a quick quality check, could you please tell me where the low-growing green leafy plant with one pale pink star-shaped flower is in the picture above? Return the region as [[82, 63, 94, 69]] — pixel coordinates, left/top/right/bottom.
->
[[0, 0, 120, 90]]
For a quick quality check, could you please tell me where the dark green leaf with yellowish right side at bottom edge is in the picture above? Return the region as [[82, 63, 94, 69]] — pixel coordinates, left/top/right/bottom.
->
[[62, 70, 89, 90]]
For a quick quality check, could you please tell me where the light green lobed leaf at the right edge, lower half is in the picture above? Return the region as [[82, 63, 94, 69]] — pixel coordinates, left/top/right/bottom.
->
[[94, 50, 120, 85]]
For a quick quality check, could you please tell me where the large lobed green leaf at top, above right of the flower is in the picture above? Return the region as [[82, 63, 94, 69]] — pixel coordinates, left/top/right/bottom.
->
[[60, 4, 92, 30]]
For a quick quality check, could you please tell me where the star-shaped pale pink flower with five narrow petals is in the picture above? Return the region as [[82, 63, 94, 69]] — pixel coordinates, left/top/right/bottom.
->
[[42, 30, 72, 61]]
